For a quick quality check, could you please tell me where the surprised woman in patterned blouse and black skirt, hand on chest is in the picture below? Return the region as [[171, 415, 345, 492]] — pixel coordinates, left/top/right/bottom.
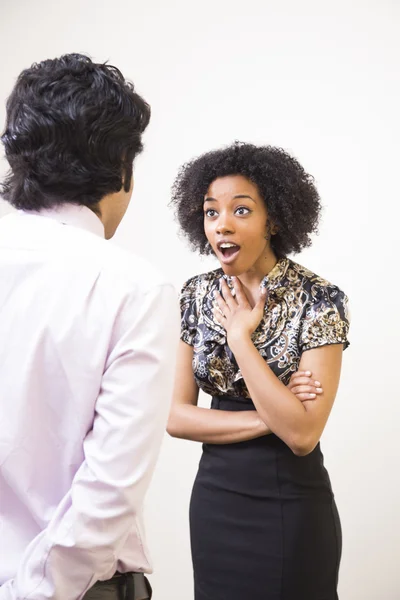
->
[[168, 143, 349, 600]]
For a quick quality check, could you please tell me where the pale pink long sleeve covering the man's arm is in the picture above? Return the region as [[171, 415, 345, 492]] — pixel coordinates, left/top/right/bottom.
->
[[0, 285, 179, 600]]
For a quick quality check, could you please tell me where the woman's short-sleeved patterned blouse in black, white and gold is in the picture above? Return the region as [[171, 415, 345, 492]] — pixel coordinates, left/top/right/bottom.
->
[[180, 258, 349, 398]]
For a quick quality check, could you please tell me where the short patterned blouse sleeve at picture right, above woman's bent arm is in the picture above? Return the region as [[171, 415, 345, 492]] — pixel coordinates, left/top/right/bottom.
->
[[300, 286, 350, 352]]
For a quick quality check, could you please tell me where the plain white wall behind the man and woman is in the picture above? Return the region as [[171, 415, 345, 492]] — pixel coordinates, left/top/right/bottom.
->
[[0, 0, 400, 600]]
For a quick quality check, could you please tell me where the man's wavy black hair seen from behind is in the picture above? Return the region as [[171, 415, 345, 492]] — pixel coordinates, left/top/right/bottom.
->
[[1, 54, 150, 210]]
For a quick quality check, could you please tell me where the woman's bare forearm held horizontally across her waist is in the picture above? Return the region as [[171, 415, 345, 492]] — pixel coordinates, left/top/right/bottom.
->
[[167, 404, 271, 444]]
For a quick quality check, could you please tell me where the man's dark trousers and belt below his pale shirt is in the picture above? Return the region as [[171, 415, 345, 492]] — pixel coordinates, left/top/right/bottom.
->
[[83, 573, 152, 600]]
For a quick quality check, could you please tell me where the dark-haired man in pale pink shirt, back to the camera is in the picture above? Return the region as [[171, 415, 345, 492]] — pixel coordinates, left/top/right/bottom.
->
[[0, 54, 179, 600]]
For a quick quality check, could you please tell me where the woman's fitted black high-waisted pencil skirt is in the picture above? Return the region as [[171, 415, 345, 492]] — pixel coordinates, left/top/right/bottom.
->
[[190, 396, 341, 600]]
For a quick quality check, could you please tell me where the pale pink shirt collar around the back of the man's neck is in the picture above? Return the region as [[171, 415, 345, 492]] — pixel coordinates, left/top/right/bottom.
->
[[21, 203, 104, 238]]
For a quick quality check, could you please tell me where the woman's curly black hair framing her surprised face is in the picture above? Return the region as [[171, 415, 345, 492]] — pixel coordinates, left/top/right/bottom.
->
[[171, 142, 321, 258]]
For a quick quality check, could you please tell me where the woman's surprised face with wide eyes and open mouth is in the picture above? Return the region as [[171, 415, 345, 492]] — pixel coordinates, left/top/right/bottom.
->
[[204, 175, 273, 276]]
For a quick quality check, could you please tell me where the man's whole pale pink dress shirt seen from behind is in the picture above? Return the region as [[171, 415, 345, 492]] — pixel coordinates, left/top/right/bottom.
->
[[0, 205, 177, 599]]
